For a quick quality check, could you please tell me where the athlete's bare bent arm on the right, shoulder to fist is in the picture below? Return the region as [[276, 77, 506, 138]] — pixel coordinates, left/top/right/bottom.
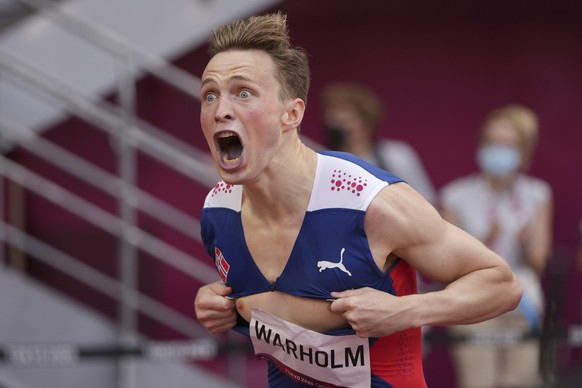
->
[[331, 184, 521, 337]]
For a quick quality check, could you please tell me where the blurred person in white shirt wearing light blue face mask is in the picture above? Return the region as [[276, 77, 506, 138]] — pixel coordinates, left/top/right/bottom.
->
[[440, 104, 553, 387]]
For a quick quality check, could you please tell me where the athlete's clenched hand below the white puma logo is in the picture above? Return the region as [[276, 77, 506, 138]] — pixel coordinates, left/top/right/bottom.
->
[[331, 287, 413, 337]]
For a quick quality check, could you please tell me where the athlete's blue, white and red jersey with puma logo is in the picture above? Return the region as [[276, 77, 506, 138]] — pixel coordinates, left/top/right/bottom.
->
[[201, 152, 426, 387]]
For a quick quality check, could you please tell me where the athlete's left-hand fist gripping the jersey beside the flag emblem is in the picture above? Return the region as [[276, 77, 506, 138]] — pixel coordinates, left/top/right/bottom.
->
[[194, 281, 237, 334]]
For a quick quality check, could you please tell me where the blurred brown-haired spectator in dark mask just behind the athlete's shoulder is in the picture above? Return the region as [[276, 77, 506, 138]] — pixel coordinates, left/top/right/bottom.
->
[[322, 83, 436, 203]]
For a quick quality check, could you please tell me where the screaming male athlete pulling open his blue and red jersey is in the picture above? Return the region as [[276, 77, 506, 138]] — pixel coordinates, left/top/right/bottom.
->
[[195, 13, 521, 387]]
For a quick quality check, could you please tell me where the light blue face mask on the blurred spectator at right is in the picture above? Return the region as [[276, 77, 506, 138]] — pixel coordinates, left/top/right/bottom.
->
[[477, 144, 521, 177]]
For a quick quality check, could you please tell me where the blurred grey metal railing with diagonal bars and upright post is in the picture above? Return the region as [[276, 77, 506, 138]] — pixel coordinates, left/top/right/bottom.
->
[[0, 0, 235, 388]]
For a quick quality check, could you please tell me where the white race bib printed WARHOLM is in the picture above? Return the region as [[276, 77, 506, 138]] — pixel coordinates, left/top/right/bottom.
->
[[250, 309, 371, 388]]
